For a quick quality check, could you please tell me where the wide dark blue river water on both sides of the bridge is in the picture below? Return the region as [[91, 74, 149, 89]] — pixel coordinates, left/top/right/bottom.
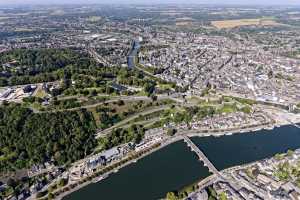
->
[[64, 126, 300, 200]]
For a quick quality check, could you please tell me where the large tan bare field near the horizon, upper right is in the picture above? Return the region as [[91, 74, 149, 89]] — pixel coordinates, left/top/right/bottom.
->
[[211, 19, 280, 29]]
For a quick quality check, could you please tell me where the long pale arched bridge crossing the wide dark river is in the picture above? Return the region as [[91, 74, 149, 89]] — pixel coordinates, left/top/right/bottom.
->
[[183, 135, 222, 177]]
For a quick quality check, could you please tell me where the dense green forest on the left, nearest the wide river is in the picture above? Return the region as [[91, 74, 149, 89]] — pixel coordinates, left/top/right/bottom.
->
[[0, 104, 96, 172]]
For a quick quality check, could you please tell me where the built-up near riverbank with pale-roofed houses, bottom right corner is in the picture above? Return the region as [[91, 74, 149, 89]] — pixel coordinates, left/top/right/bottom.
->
[[188, 148, 300, 199]]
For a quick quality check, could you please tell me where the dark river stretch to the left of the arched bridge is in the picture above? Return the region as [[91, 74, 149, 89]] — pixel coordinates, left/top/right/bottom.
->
[[64, 141, 209, 200]]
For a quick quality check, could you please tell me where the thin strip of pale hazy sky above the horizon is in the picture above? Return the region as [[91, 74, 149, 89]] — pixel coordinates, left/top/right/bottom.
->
[[0, 0, 300, 5]]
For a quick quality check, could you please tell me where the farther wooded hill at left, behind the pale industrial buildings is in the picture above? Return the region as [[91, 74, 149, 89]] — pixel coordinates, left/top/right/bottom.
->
[[0, 49, 95, 86]]
